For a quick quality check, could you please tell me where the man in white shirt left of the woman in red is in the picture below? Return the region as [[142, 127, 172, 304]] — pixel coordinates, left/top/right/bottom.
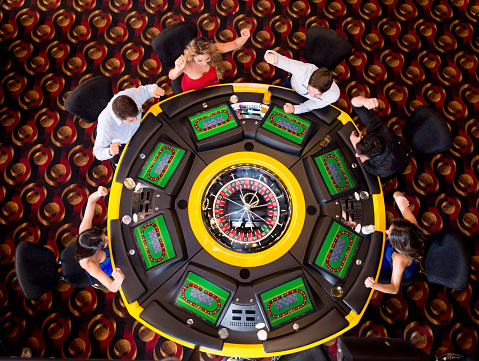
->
[[93, 84, 165, 163]]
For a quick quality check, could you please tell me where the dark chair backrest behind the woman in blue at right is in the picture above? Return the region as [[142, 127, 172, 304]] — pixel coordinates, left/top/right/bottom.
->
[[424, 232, 471, 291]]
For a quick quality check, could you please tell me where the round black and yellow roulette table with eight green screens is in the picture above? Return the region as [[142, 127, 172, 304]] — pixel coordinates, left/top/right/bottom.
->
[[108, 84, 385, 357]]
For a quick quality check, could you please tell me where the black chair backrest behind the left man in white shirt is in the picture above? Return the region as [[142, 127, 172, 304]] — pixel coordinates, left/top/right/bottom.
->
[[65, 76, 114, 123]]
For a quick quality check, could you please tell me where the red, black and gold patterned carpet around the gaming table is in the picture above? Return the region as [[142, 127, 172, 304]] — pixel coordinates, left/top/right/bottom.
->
[[0, 0, 479, 361]]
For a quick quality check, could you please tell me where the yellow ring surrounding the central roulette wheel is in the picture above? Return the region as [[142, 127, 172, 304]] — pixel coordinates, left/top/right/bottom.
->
[[188, 152, 305, 267]]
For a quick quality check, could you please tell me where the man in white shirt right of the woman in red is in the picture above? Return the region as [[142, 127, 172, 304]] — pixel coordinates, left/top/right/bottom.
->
[[264, 50, 339, 114]]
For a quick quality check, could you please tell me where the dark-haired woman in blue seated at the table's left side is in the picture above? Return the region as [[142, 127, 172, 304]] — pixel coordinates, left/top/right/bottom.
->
[[75, 186, 125, 292]]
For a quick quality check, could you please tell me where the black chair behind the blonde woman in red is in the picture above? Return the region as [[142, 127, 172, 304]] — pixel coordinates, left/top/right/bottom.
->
[[151, 21, 198, 94]]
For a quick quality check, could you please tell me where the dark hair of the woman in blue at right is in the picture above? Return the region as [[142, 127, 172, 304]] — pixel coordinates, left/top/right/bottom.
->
[[389, 218, 424, 262]]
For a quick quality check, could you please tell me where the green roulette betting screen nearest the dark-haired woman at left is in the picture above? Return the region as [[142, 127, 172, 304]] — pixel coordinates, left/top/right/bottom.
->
[[134, 215, 176, 269]]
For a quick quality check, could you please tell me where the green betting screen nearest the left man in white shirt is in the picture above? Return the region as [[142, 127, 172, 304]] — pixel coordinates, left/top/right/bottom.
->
[[138, 143, 185, 188]]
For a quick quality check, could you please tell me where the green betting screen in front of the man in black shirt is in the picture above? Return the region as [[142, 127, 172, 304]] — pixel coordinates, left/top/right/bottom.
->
[[314, 149, 355, 195]]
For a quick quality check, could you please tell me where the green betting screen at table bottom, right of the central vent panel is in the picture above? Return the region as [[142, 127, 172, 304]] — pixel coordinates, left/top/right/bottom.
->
[[260, 277, 313, 327]]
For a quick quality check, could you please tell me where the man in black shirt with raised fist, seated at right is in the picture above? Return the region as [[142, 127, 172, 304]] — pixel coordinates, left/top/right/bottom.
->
[[350, 96, 409, 178]]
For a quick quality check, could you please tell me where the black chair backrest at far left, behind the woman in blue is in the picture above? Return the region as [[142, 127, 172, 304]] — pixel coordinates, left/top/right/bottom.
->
[[15, 241, 60, 300]]
